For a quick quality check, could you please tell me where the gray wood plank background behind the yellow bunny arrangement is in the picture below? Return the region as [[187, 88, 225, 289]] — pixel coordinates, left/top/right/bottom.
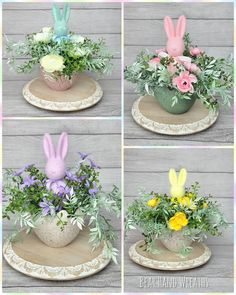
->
[[124, 148, 234, 293]]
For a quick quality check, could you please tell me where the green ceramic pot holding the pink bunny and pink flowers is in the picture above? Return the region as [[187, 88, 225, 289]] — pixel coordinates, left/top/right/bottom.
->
[[154, 87, 197, 114]]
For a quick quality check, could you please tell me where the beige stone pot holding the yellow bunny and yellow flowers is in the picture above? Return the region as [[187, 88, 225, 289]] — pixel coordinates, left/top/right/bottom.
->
[[160, 231, 193, 252]]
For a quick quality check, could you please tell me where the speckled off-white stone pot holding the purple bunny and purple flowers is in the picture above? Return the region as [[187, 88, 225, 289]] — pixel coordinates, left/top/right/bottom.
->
[[34, 211, 80, 248]]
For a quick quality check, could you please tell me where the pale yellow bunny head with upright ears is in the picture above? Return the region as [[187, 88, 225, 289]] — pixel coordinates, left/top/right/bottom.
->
[[169, 168, 187, 198]]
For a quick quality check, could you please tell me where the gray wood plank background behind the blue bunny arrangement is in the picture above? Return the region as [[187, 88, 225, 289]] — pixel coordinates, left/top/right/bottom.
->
[[2, 2, 121, 117]]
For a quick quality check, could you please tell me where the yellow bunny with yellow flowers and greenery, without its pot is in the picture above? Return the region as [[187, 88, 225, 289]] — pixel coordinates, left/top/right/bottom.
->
[[126, 169, 228, 252]]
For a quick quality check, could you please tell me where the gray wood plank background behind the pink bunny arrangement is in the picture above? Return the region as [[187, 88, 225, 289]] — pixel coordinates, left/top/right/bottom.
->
[[124, 2, 234, 145]]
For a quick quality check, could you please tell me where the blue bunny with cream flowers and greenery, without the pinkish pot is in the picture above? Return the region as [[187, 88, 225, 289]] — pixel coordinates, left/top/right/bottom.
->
[[6, 5, 112, 79]]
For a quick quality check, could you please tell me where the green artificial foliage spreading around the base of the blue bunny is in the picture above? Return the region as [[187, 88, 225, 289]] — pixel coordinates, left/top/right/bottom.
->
[[6, 28, 112, 78]]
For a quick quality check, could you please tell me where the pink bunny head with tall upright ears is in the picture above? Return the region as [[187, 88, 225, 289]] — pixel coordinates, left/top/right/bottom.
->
[[164, 15, 186, 57]]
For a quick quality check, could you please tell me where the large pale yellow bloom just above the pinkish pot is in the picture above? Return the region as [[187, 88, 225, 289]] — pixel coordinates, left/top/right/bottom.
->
[[40, 54, 65, 73]]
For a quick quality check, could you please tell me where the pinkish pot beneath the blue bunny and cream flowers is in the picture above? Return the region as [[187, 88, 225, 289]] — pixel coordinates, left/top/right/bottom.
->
[[41, 68, 75, 91]]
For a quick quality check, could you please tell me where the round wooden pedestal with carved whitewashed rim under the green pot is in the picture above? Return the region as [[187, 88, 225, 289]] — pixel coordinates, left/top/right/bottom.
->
[[132, 95, 219, 135]]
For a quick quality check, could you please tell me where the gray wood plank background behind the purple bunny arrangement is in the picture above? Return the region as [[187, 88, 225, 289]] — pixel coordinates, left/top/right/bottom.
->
[[3, 119, 121, 293]]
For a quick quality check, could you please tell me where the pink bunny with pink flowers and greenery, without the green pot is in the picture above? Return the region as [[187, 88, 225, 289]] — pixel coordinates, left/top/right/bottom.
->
[[125, 16, 233, 110]]
